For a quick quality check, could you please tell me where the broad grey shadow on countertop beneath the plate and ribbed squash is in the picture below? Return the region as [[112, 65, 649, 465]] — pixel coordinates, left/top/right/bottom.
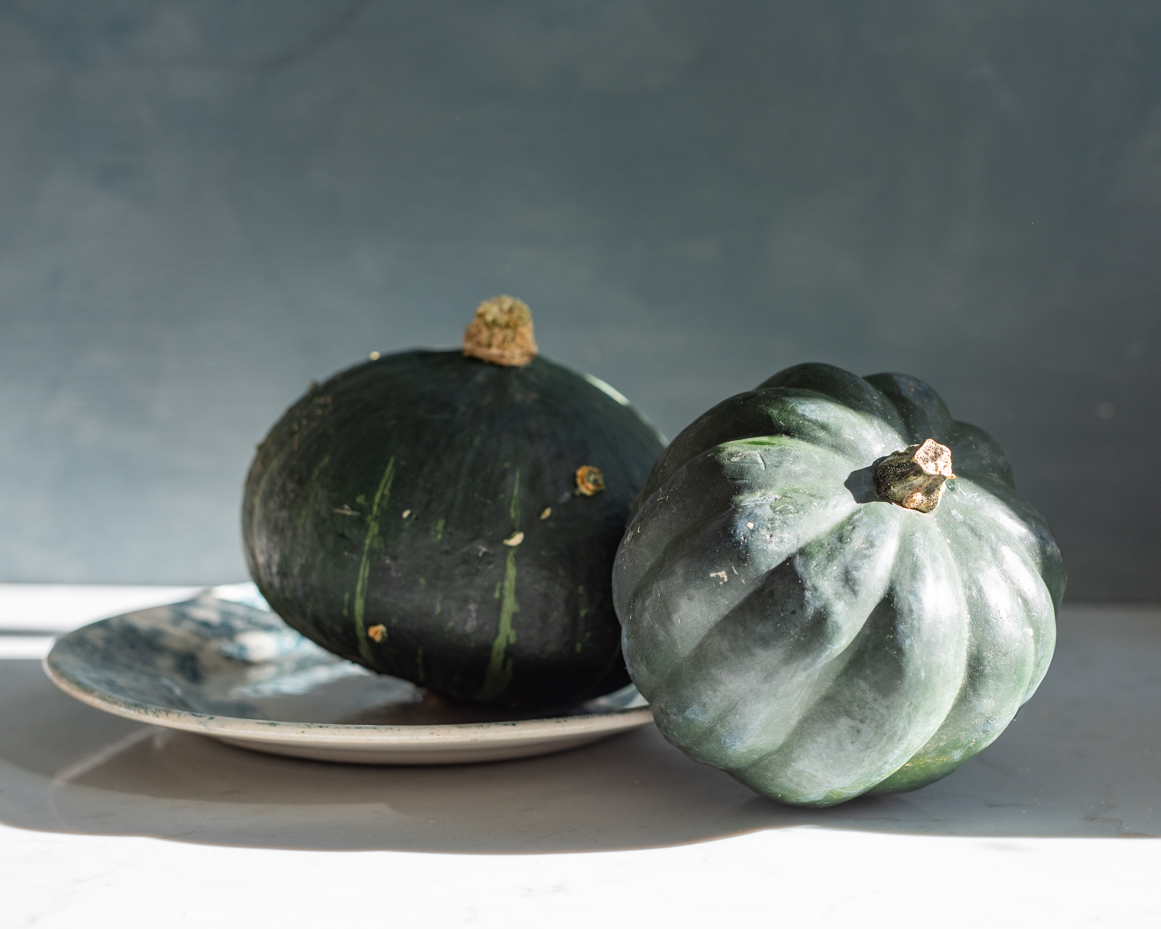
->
[[0, 606, 1161, 854]]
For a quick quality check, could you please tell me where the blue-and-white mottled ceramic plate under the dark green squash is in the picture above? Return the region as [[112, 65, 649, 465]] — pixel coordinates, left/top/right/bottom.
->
[[44, 584, 652, 764]]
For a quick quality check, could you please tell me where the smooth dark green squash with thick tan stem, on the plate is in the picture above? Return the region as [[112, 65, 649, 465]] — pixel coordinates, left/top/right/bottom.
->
[[243, 297, 663, 707]]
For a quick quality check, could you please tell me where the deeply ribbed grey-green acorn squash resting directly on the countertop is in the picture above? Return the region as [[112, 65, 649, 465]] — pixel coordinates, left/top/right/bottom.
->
[[613, 365, 1065, 806]]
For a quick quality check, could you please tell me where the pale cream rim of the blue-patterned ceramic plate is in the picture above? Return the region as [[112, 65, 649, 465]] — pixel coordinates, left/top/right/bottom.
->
[[41, 597, 652, 748]]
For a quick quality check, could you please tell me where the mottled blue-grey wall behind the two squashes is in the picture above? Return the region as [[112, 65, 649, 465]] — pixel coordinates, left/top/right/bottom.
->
[[0, 0, 1161, 599]]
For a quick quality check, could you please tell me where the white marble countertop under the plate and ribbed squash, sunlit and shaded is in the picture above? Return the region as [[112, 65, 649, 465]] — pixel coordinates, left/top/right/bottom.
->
[[0, 584, 1161, 929]]
